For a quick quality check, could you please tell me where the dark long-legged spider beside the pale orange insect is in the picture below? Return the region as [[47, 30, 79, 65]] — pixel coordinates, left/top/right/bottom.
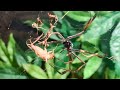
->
[[44, 13, 104, 74]]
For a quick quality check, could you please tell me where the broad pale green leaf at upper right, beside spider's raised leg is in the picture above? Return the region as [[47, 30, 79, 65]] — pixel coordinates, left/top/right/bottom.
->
[[80, 12, 120, 46]]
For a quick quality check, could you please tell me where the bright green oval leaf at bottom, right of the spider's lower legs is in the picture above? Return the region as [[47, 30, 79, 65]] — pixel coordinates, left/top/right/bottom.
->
[[84, 56, 102, 79]]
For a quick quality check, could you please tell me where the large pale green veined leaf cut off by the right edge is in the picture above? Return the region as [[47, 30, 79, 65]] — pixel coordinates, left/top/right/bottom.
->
[[110, 18, 120, 78]]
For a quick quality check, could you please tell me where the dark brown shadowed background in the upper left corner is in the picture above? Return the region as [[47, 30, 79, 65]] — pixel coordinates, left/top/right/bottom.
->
[[0, 11, 51, 48]]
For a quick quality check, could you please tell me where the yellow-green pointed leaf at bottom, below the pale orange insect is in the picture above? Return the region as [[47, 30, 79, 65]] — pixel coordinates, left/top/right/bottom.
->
[[23, 64, 48, 79]]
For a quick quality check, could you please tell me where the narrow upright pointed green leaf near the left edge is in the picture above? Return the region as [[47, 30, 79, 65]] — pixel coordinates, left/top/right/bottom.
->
[[7, 34, 15, 62]]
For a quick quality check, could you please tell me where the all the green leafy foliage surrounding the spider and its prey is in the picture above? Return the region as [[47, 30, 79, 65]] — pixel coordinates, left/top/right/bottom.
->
[[0, 11, 120, 79]]
